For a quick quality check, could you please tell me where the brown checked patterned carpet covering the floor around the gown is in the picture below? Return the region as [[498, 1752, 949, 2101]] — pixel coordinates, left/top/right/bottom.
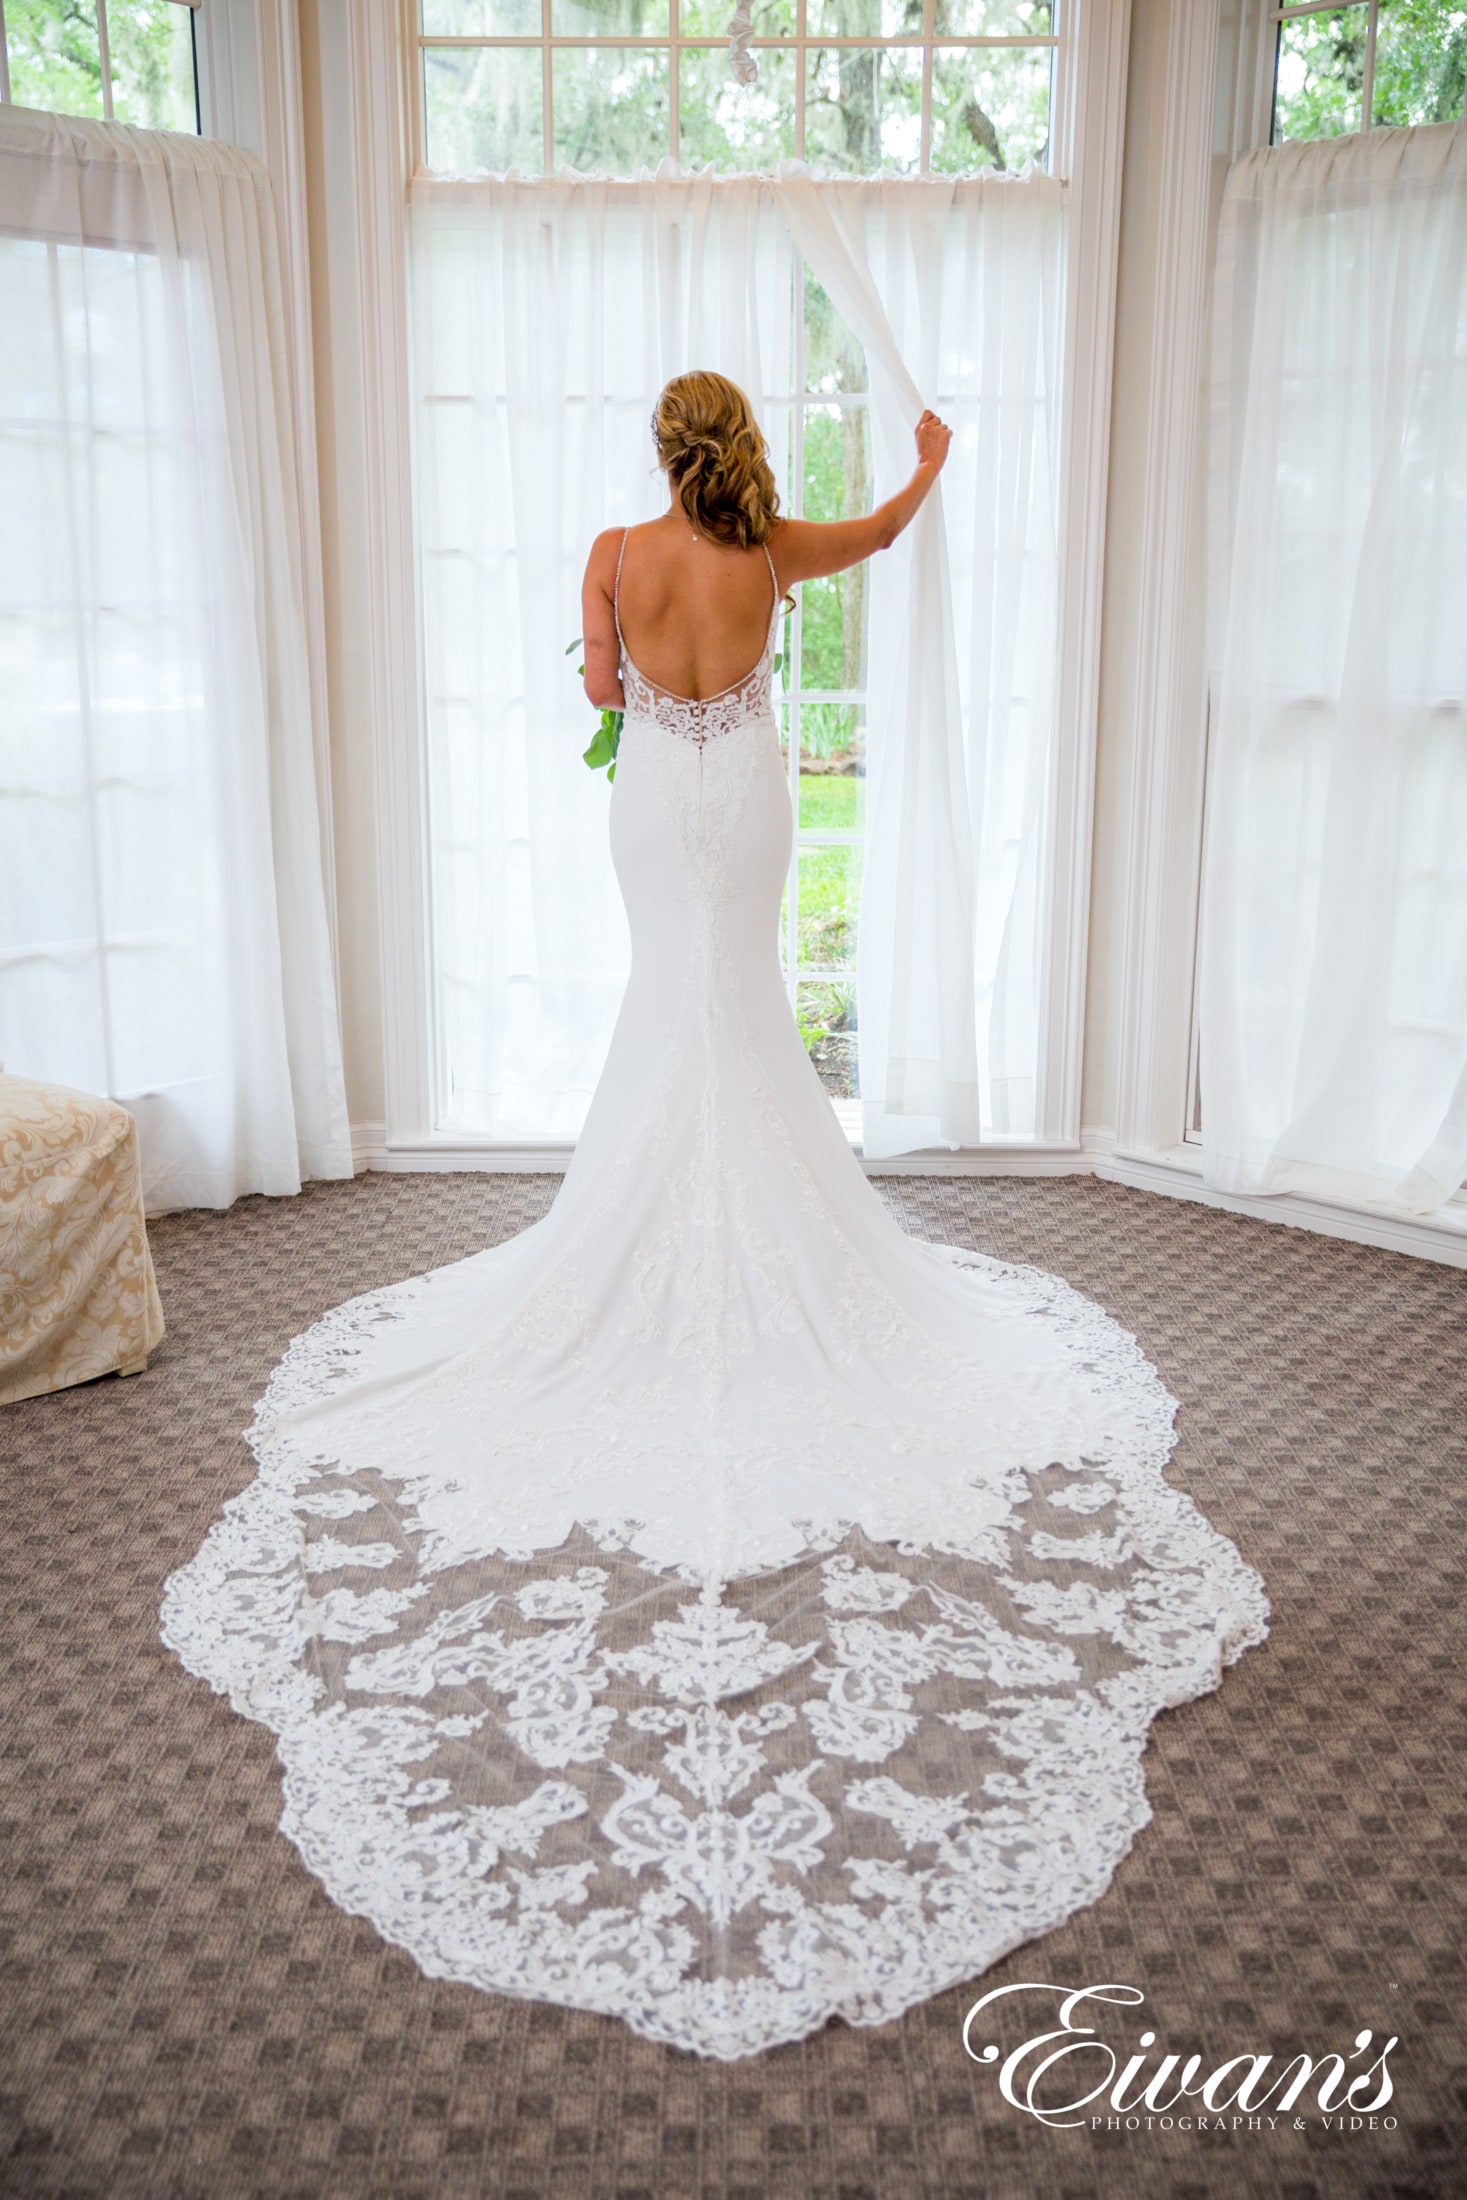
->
[[0, 1175, 1467, 2200]]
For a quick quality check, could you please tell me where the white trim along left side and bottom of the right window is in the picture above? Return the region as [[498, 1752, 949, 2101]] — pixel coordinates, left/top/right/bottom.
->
[[1112, 0, 1467, 1267]]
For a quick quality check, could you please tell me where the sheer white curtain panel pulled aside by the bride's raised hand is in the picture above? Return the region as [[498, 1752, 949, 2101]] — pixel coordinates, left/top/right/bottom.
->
[[776, 172, 1065, 1159]]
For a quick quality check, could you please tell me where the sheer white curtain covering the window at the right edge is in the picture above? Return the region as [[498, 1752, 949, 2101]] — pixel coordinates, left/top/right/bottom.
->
[[1201, 123, 1467, 1212]]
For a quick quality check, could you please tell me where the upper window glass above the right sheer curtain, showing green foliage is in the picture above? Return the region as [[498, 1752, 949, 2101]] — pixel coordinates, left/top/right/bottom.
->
[[1269, 0, 1467, 145]]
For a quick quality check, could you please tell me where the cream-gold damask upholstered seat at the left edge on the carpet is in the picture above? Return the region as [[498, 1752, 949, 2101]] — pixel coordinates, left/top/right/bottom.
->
[[0, 1074, 163, 1404]]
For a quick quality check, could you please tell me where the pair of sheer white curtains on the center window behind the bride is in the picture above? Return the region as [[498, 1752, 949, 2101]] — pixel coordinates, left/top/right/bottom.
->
[[413, 167, 1065, 1155]]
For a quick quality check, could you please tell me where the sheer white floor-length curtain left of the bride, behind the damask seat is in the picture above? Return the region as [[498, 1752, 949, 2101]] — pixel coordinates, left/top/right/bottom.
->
[[0, 108, 352, 1210]]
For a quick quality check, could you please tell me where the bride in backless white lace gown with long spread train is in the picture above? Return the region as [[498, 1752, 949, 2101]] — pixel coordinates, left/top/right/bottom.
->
[[163, 374, 1267, 2057]]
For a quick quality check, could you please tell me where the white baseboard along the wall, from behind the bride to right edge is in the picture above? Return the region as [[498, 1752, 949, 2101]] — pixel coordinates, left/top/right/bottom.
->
[[352, 1122, 1467, 1267]]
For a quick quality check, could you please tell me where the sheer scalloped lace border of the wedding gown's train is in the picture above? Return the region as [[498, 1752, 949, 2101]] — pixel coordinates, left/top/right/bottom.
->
[[163, 1254, 1267, 2059]]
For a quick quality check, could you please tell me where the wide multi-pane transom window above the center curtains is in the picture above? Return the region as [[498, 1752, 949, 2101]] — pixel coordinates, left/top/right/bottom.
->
[[417, 0, 1056, 176]]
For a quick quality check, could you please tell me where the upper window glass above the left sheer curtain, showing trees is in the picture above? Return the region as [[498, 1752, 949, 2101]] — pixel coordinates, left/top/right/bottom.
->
[[0, 0, 200, 134]]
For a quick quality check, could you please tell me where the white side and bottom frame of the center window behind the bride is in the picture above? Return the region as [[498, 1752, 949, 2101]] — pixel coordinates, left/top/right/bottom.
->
[[321, 0, 1130, 1173]]
